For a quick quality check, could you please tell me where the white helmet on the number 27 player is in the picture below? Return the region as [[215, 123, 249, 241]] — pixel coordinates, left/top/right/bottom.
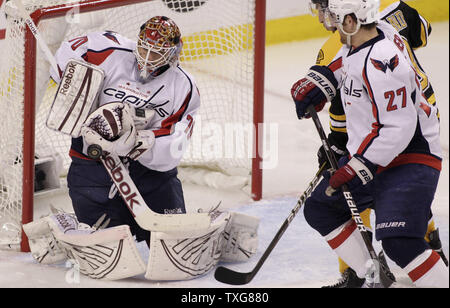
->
[[328, 0, 380, 25]]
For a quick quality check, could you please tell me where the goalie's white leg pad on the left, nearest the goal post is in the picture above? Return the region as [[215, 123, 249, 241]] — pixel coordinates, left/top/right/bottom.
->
[[27, 213, 145, 280]]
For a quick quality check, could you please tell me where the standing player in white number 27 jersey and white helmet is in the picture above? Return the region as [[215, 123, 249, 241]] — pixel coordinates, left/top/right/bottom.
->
[[292, 0, 448, 287]]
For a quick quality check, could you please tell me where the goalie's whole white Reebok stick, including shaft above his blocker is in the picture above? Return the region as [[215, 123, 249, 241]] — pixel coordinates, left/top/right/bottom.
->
[[13, 0, 211, 232]]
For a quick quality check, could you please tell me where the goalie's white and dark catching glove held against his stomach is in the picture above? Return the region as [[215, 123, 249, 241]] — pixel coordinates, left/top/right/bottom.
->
[[81, 102, 155, 159]]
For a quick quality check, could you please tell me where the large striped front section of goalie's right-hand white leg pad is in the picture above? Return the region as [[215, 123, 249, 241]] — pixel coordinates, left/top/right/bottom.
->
[[145, 213, 230, 280]]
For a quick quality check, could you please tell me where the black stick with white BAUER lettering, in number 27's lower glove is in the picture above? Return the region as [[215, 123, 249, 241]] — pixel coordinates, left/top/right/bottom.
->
[[308, 105, 393, 288]]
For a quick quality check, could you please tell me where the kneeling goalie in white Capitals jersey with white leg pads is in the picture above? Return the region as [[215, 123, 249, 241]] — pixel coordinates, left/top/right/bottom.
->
[[24, 16, 259, 280]]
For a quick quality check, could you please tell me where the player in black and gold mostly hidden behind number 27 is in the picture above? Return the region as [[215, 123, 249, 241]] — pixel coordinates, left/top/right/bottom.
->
[[310, 0, 448, 288]]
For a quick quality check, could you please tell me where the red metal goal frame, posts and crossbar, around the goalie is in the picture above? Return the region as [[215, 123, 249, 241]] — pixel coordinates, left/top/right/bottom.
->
[[20, 0, 266, 251]]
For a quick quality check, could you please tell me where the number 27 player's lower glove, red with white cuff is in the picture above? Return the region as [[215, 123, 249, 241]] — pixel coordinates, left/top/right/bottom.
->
[[329, 154, 377, 190]]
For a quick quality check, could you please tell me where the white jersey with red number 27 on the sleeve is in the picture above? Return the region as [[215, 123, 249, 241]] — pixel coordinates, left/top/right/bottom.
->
[[329, 29, 441, 170]]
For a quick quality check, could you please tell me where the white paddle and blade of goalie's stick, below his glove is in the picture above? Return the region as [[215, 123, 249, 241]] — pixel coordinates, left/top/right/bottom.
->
[[100, 153, 211, 232]]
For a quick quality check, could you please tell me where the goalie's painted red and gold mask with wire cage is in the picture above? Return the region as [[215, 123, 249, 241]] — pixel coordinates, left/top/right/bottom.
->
[[134, 16, 183, 79]]
